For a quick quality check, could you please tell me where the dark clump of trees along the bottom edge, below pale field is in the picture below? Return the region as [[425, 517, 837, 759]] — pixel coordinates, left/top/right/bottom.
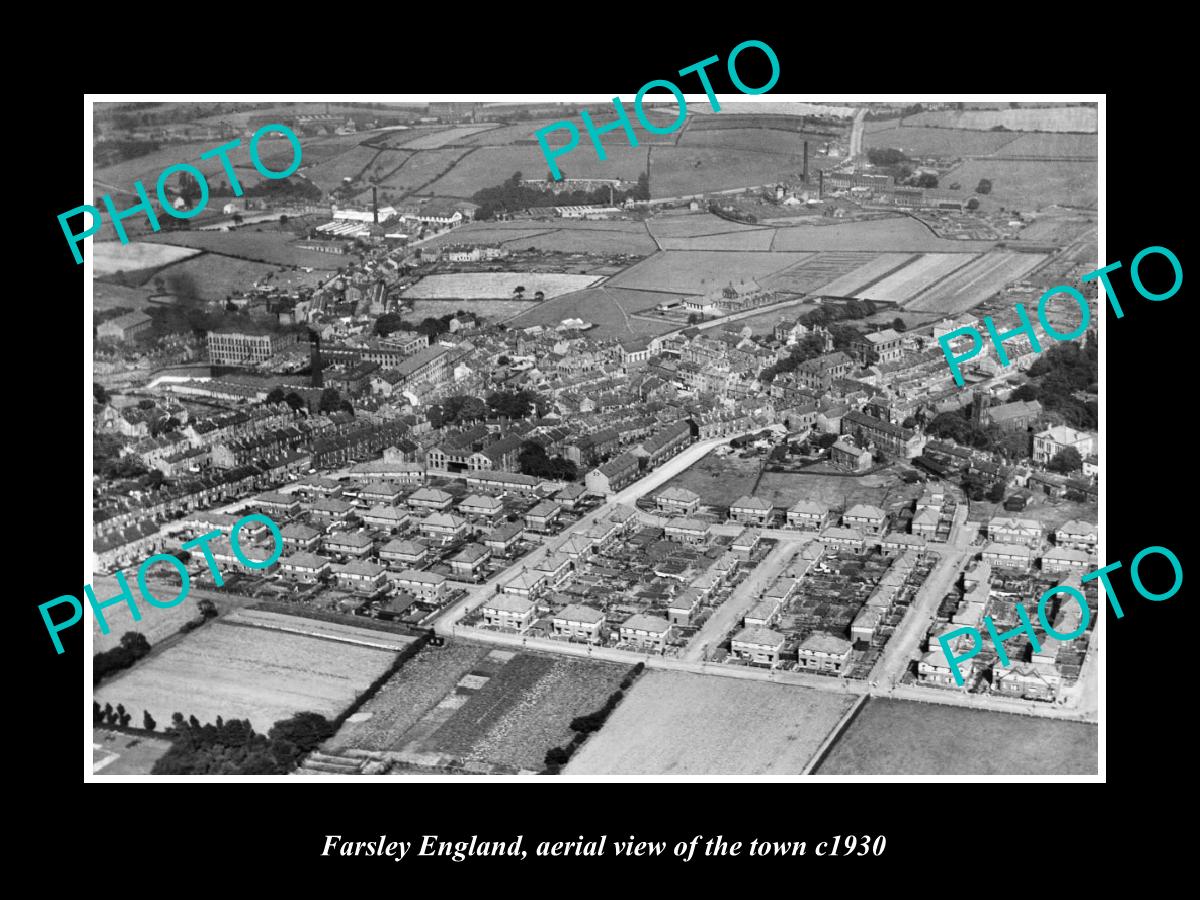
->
[[150, 713, 335, 775]]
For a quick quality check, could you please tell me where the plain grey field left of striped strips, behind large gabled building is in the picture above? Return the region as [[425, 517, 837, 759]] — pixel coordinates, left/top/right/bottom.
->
[[610, 250, 806, 294]]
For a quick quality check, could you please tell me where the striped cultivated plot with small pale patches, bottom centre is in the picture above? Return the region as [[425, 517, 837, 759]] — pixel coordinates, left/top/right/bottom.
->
[[329, 642, 629, 770]]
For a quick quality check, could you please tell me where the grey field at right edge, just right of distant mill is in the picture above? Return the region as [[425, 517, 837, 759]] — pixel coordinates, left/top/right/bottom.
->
[[943, 160, 1097, 212]]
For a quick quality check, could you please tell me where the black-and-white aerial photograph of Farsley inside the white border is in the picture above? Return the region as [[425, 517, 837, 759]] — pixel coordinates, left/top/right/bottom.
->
[[87, 95, 1104, 781]]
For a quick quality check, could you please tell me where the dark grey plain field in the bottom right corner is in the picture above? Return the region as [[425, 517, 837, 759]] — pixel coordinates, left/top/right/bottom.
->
[[815, 698, 1099, 775]]
